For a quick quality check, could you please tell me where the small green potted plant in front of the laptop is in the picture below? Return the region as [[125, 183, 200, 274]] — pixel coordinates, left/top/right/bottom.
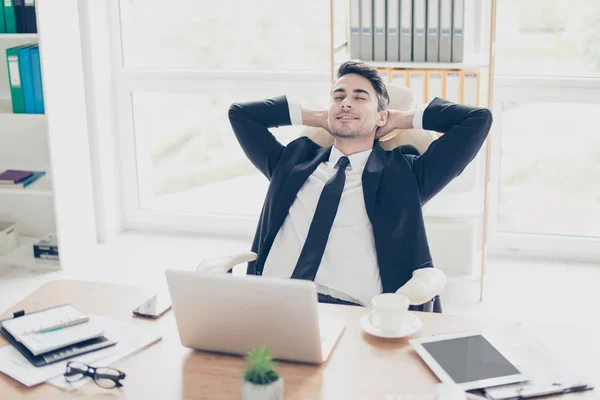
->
[[242, 346, 283, 400]]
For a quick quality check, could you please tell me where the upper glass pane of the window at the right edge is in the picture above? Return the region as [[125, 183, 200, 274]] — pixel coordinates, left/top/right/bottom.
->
[[495, 0, 600, 77]]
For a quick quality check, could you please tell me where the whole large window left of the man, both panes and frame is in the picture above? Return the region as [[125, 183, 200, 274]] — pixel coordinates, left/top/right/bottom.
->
[[112, 0, 332, 230]]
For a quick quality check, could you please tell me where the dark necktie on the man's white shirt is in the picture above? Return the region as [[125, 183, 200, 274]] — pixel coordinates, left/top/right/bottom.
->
[[292, 156, 350, 281]]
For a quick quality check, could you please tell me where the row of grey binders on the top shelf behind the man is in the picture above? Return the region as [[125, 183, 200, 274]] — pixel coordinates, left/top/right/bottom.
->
[[349, 0, 465, 62]]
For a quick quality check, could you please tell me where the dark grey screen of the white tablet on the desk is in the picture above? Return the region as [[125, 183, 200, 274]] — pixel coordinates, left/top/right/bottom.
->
[[422, 335, 521, 384]]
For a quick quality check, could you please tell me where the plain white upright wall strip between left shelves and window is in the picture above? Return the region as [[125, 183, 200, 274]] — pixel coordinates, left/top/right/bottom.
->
[[36, 0, 96, 269]]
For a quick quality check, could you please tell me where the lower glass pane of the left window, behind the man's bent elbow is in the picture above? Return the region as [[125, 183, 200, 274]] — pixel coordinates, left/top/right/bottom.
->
[[132, 81, 330, 215]]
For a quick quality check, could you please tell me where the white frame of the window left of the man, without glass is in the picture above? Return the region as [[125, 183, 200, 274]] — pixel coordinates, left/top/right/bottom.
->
[[109, 1, 331, 238]]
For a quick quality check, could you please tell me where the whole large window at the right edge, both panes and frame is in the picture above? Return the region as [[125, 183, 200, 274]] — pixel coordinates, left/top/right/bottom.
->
[[491, 0, 600, 254]]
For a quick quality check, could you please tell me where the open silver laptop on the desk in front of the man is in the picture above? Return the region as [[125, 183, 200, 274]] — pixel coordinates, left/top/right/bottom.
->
[[166, 270, 345, 364]]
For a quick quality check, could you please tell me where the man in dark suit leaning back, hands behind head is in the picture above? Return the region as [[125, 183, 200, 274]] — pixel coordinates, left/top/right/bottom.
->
[[229, 61, 492, 305]]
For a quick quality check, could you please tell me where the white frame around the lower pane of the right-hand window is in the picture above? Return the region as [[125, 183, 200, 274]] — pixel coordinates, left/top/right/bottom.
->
[[487, 76, 600, 259]]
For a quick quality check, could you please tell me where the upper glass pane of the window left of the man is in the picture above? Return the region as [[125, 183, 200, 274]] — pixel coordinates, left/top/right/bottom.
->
[[120, 0, 331, 72]]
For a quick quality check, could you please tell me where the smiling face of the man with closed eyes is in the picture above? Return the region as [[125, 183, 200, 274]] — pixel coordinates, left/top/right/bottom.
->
[[329, 74, 380, 139]]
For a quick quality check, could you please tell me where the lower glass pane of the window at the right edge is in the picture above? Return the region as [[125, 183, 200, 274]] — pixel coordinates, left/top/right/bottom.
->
[[498, 102, 600, 237]]
